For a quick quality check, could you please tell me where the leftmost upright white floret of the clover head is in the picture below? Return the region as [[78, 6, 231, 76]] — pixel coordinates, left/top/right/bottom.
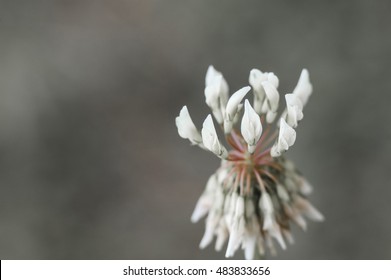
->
[[175, 106, 202, 144]]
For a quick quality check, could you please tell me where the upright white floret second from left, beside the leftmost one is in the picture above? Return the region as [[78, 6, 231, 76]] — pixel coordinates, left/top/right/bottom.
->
[[201, 114, 228, 158]]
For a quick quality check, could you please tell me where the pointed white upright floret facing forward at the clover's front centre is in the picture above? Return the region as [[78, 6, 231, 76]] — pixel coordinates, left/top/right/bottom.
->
[[241, 99, 262, 153]]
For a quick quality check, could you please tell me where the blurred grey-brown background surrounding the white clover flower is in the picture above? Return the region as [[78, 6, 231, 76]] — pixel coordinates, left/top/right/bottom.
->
[[0, 0, 391, 259]]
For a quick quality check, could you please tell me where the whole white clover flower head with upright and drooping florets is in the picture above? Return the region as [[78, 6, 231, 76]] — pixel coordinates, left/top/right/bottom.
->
[[175, 66, 323, 259]]
